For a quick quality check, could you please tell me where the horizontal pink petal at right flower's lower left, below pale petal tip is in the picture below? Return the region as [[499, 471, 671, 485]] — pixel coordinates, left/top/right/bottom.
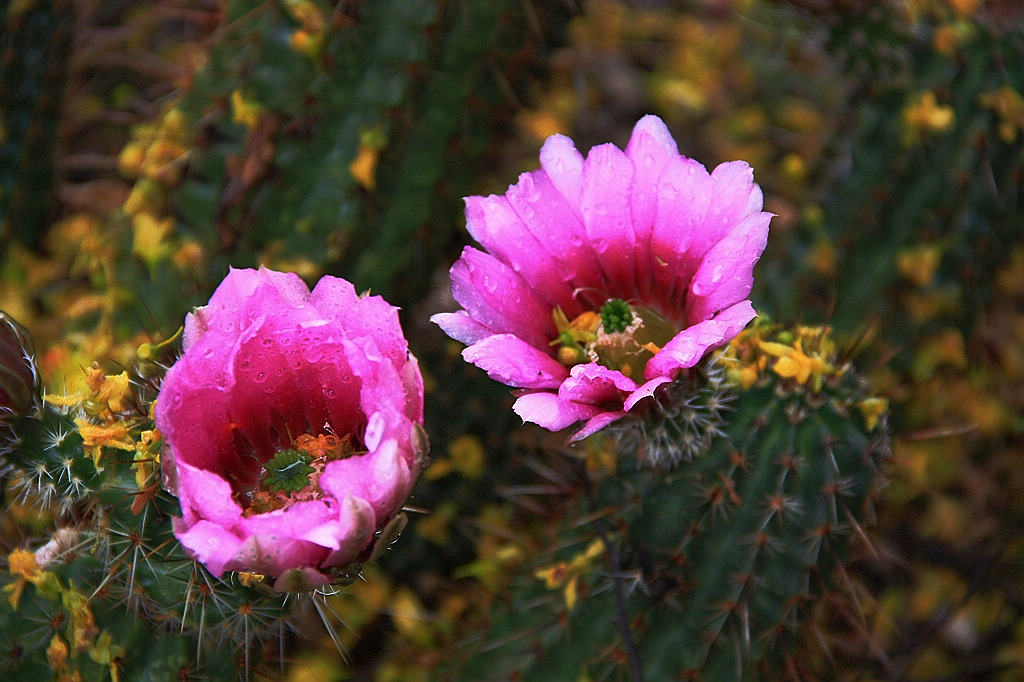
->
[[462, 334, 569, 388]]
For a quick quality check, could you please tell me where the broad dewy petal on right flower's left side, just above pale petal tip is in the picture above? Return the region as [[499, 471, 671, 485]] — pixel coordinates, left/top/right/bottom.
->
[[452, 247, 556, 346]]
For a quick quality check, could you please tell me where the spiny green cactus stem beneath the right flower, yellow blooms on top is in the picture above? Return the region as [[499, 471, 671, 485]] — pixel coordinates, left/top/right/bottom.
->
[[452, 324, 889, 680]]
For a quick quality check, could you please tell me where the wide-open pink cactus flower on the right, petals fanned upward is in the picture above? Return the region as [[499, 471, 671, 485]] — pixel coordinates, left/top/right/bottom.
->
[[433, 116, 771, 440]]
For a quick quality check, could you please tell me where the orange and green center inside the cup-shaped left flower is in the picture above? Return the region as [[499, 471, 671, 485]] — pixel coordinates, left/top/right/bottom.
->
[[239, 433, 366, 517]]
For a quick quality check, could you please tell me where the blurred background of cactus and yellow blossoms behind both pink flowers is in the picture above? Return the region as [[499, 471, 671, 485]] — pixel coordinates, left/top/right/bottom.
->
[[0, 0, 1024, 682]]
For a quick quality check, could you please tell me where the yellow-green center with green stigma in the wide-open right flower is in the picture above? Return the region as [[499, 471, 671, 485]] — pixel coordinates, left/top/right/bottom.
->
[[551, 298, 679, 378]]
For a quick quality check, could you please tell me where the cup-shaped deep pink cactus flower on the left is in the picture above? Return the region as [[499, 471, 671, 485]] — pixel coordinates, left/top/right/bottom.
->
[[156, 268, 426, 591]]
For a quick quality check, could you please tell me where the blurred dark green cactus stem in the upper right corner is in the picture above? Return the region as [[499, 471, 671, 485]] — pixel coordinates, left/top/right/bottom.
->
[[763, 3, 1024, 339]]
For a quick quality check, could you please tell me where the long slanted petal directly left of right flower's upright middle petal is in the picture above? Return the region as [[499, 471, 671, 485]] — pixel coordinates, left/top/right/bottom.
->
[[505, 170, 605, 308]]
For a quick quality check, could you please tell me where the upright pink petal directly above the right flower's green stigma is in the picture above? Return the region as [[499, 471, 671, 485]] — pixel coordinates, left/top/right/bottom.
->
[[580, 144, 637, 294]]
